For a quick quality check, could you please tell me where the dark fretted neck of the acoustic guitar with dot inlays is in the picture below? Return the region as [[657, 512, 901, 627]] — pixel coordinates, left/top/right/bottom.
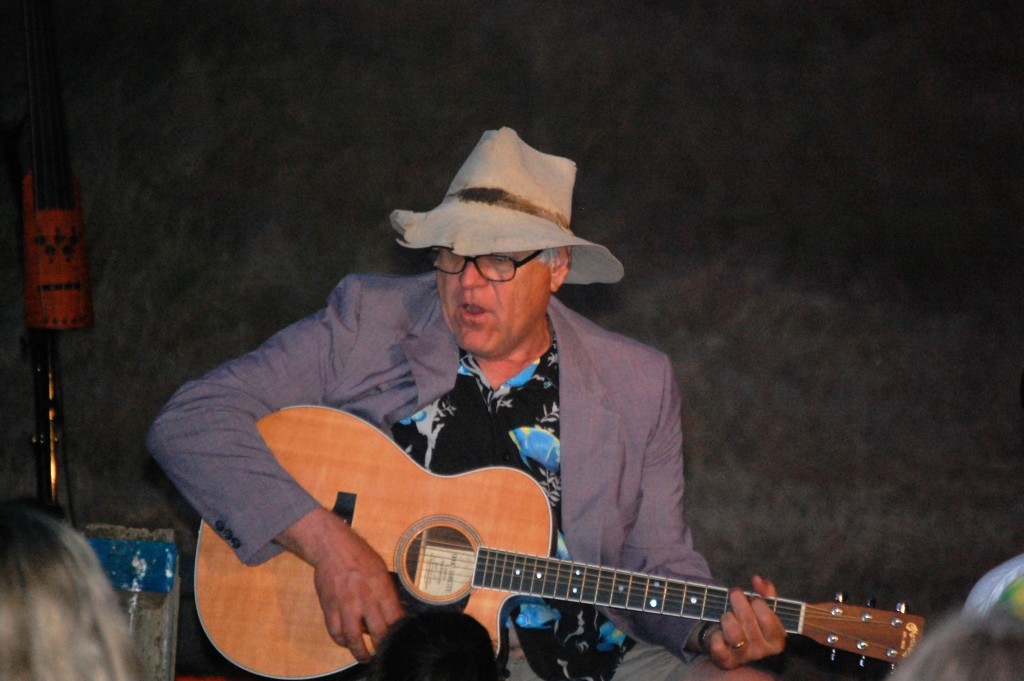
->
[[473, 548, 805, 634]]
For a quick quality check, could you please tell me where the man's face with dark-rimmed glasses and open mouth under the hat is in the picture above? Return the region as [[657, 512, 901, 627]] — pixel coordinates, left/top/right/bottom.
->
[[437, 248, 569, 364]]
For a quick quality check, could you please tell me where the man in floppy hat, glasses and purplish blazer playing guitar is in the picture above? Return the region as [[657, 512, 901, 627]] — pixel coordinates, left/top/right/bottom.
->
[[147, 128, 785, 680]]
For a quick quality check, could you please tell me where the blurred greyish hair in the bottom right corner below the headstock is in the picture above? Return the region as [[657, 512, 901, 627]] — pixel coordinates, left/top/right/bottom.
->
[[890, 608, 1024, 681]]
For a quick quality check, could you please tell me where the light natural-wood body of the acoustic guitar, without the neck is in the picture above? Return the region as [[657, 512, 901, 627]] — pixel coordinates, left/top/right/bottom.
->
[[196, 407, 552, 678]]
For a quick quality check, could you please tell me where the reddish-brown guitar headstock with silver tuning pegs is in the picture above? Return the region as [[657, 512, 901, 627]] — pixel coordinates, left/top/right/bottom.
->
[[801, 601, 925, 663]]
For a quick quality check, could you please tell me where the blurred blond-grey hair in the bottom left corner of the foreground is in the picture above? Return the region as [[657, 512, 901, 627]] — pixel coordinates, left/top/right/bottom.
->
[[0, 502, 137, 681]]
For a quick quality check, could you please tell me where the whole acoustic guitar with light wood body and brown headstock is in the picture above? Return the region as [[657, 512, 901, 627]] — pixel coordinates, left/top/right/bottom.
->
[[196, 407, 924, 679]]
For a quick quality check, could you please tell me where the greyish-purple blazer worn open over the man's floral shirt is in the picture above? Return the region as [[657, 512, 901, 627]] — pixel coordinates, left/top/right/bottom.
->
[[146, 272, 710, 655]]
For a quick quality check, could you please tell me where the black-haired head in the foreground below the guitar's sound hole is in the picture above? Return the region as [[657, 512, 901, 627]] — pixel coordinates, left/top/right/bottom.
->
[[370, 610, 498, 681]]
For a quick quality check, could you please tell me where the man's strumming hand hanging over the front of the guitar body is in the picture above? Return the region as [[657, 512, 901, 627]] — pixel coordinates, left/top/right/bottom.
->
[[276, 508, 402, 663]]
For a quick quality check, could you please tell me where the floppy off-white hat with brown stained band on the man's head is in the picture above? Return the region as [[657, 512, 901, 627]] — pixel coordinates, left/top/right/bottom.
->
[[391, 128, 623, 284]]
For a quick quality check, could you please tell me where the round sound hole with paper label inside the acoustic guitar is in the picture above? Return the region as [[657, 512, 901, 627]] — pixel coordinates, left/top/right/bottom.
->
[[395, 518, 479, 605]]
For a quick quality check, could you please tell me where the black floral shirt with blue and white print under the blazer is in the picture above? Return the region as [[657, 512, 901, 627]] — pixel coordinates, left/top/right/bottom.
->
[[392, 333, 634, 681]]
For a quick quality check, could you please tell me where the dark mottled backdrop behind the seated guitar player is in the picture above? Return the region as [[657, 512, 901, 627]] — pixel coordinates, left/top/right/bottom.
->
[[0, 0, 1024, 678]]
